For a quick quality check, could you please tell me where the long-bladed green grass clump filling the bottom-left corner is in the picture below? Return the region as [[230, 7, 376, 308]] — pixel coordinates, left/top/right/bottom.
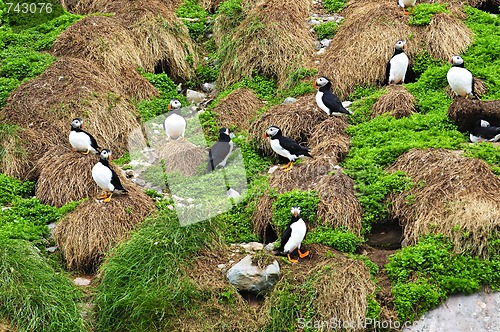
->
[[0, 236, 86, 332]]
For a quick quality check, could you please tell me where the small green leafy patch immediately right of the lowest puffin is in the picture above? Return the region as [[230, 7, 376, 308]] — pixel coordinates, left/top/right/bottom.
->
[[304, 225, 362, 253]]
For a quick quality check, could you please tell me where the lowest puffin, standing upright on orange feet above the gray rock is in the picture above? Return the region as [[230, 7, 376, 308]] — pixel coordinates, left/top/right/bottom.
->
[[278, 206, 309, 263]]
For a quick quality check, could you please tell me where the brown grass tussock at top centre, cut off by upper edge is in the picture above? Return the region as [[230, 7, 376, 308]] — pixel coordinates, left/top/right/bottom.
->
[[218, 0, 314, 89]]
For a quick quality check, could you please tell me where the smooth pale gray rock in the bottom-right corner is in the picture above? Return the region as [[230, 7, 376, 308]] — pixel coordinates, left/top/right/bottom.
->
[[403, 292, 500, 332]]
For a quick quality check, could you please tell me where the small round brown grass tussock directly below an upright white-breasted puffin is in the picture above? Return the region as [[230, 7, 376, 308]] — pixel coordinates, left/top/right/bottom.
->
[[372, 85, 415, 119]]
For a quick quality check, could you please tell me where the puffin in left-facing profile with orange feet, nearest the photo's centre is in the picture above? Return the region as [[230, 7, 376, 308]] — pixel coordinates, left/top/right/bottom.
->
[[262, 126, 312, 172]]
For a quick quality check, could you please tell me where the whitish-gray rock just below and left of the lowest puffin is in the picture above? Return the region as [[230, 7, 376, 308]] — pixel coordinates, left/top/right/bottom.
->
[[226, 255, 280, 294]]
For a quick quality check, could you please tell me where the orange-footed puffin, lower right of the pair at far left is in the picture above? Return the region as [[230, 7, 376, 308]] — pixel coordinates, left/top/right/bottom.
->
[[92, 149, 127, 203]]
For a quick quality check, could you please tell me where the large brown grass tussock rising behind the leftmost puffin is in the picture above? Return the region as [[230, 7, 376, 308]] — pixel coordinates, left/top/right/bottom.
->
[[0, 57, 143, 182]]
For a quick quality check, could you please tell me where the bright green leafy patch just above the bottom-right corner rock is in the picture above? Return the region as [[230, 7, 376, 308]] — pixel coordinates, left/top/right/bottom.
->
[[386, 235, 500, 321]]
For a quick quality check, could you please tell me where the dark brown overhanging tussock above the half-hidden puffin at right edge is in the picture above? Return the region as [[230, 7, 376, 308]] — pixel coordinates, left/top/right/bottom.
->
[[448, 98, 500, 132]]
